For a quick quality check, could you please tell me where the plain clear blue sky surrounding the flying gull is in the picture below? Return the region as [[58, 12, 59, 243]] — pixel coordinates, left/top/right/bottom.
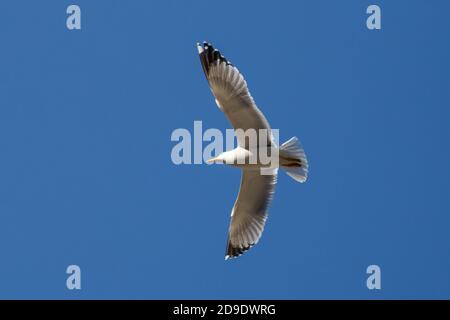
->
[[0, 0, 450, 299]]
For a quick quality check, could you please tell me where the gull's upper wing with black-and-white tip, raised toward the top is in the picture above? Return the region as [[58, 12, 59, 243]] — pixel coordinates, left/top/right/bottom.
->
[[197, 42, 273, 149]]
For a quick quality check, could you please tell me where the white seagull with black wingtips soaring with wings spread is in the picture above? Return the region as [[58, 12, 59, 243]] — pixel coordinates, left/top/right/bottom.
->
[[197, 42, 308, 260]]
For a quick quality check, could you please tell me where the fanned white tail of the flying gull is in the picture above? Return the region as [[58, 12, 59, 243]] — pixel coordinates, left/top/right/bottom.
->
[[279, 137, 308, 182]]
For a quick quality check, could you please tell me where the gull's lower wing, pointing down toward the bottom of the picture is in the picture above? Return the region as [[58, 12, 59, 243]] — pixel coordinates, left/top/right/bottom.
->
[[225, 169, 277, 259]]
